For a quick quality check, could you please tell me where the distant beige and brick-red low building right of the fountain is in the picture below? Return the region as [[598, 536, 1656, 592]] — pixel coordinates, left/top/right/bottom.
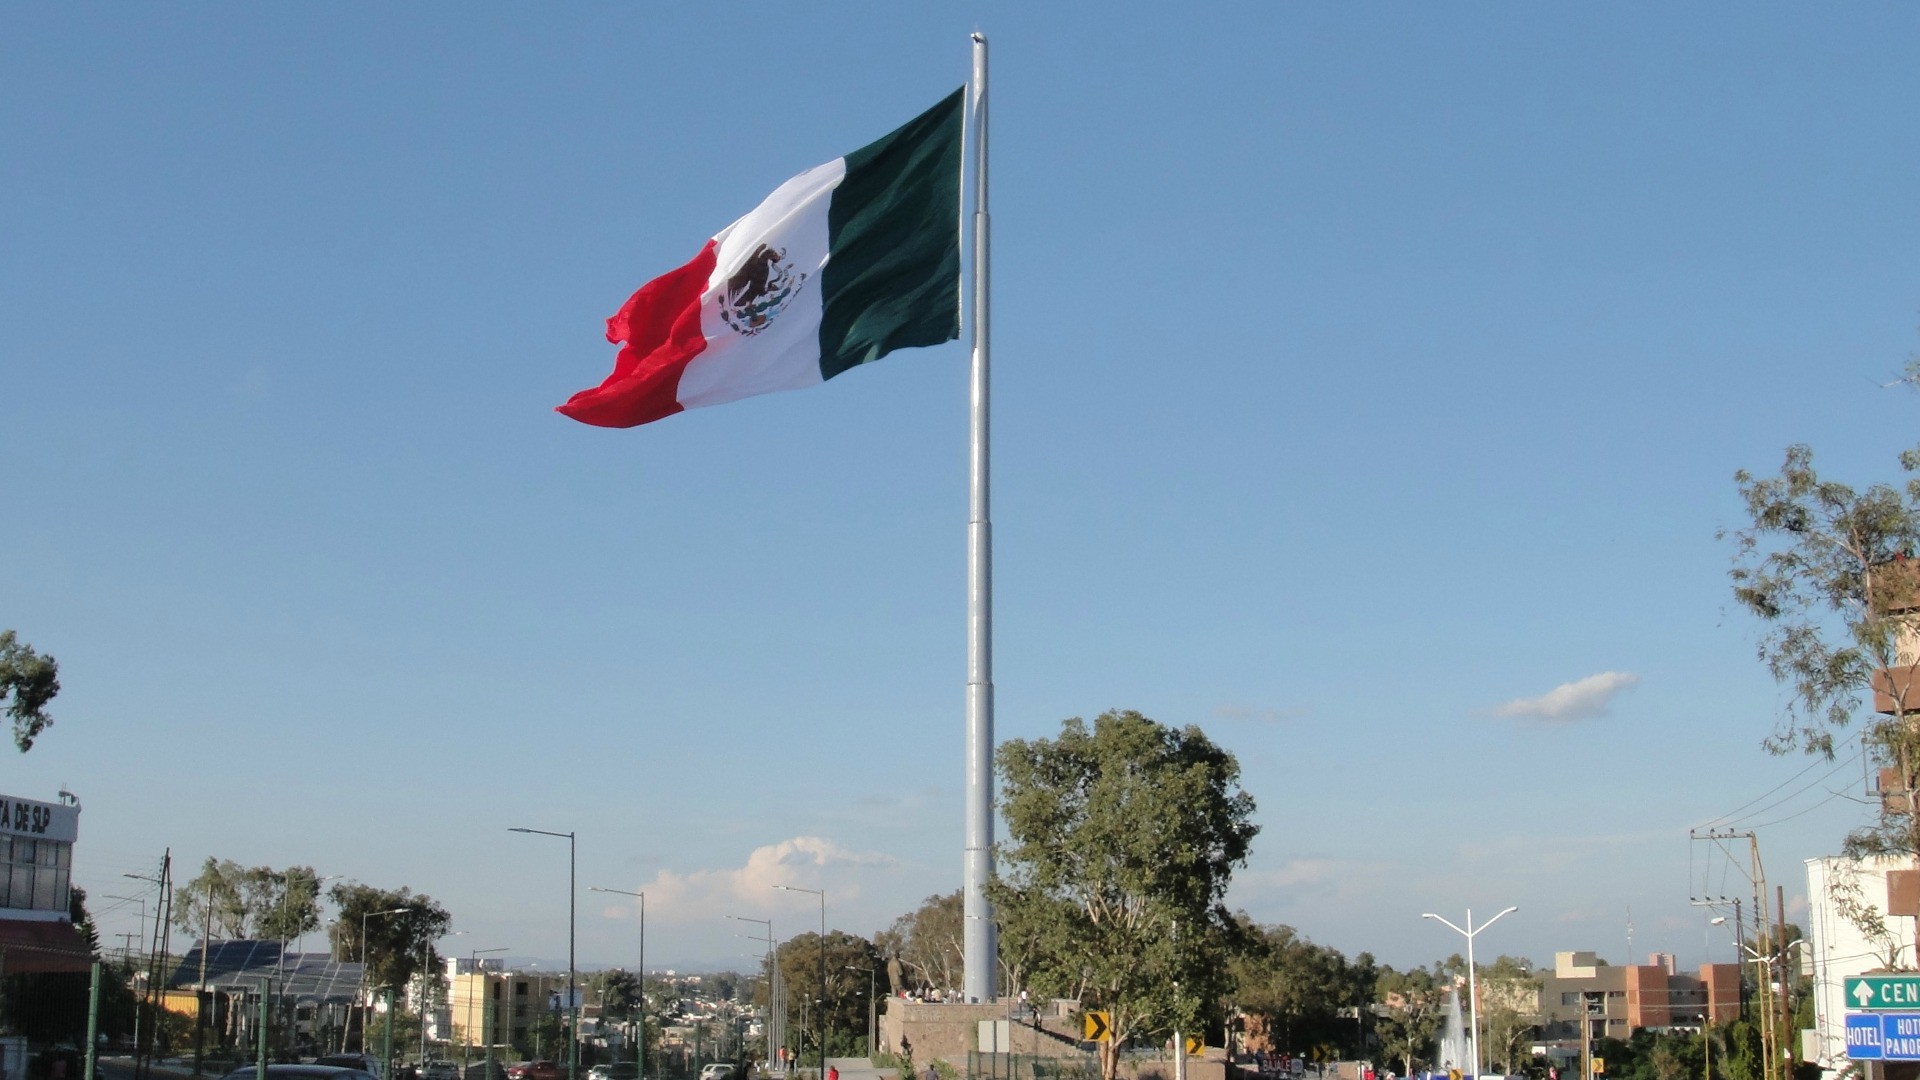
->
[[1536, 951, 1740, 1063]]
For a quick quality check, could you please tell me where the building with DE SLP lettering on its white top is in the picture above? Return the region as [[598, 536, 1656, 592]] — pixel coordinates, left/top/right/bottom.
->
[[0, 780, 94, 974]]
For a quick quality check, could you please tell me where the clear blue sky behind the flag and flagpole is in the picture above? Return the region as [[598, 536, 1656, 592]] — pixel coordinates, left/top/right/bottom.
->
[[0, 4, 1920, 967]]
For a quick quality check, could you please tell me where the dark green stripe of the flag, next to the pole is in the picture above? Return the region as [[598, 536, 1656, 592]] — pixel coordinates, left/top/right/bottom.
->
[[820, 88, 964, 379]]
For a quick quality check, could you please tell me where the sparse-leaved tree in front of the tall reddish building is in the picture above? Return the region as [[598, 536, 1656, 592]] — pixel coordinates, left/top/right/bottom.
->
[[1732, 446, 1920, 953]]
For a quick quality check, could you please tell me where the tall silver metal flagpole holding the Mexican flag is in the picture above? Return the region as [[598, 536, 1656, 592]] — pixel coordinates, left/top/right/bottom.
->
[[962, 33, 1000, 1001]]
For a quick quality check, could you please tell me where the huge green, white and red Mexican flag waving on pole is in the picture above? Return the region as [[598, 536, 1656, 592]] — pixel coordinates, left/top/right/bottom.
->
[[559, 90, 962, 427]]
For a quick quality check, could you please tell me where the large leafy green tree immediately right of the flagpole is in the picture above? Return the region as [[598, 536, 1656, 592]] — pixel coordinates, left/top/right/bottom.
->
[[991, 711, 1258, 1080]]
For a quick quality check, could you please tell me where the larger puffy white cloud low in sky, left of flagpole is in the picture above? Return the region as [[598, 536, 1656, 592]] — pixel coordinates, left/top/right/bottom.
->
[[601, 836, 899, 920]]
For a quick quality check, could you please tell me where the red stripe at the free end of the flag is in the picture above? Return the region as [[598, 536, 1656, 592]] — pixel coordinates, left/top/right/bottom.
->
[[555, 240, 720, 427]]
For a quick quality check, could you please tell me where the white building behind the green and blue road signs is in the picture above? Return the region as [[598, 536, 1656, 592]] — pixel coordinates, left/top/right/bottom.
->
[[1801, 855, 1914, 1070]]
